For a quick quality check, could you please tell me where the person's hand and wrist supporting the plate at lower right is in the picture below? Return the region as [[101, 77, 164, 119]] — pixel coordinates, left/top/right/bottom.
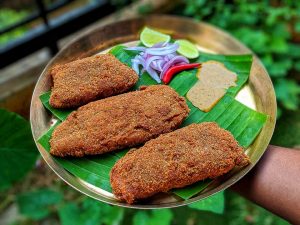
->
[[231, 145, 300, 224]]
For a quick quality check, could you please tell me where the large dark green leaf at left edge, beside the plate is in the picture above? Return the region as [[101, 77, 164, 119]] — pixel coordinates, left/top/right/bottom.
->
[[0, 109, 38, 191]]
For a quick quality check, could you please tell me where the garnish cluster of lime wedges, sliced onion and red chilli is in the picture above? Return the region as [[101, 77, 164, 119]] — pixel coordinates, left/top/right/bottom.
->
[[125, 27, 203, 84]]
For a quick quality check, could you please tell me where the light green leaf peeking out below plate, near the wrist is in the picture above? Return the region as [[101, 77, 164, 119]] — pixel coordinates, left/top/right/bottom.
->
[[188, 191, 225, 214]]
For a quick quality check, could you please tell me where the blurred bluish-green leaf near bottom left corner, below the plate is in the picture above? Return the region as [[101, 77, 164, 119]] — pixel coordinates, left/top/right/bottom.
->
[[17, 189, 63, 220]]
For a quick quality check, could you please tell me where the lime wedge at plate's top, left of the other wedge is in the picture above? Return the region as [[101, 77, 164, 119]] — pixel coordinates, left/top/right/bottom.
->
[[140, 27, 171, 47]]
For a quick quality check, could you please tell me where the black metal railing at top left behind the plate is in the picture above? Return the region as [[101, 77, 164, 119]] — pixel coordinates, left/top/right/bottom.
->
[[0, 0, 122, 68]]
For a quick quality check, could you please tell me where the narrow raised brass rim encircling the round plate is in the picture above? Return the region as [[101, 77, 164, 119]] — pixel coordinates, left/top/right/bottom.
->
[[30, 15, 277, 209]]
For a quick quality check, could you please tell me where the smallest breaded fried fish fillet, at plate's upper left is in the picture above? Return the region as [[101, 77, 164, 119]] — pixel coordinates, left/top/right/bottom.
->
[[50, 54, 138, 108]]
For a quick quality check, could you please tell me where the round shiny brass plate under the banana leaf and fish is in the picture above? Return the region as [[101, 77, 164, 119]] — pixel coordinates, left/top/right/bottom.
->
[[30, 16, 276, 209]]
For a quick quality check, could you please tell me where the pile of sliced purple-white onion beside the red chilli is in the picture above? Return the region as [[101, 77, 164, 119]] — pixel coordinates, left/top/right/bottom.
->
[[125, 42, 189, 83]]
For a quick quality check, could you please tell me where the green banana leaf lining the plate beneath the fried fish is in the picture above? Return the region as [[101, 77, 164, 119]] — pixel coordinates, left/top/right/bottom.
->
[[35, 46, 267, 199]]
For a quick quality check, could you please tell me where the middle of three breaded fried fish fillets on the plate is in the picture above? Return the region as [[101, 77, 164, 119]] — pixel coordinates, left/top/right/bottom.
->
[[50, 85, 189, 157]]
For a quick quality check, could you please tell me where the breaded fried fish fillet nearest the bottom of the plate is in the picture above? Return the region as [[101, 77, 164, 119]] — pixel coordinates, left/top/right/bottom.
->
[[110, 122, 249, 204]]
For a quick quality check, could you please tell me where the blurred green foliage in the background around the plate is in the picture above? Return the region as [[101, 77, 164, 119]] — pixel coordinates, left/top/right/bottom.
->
[[0, 0, 300, 225]]
